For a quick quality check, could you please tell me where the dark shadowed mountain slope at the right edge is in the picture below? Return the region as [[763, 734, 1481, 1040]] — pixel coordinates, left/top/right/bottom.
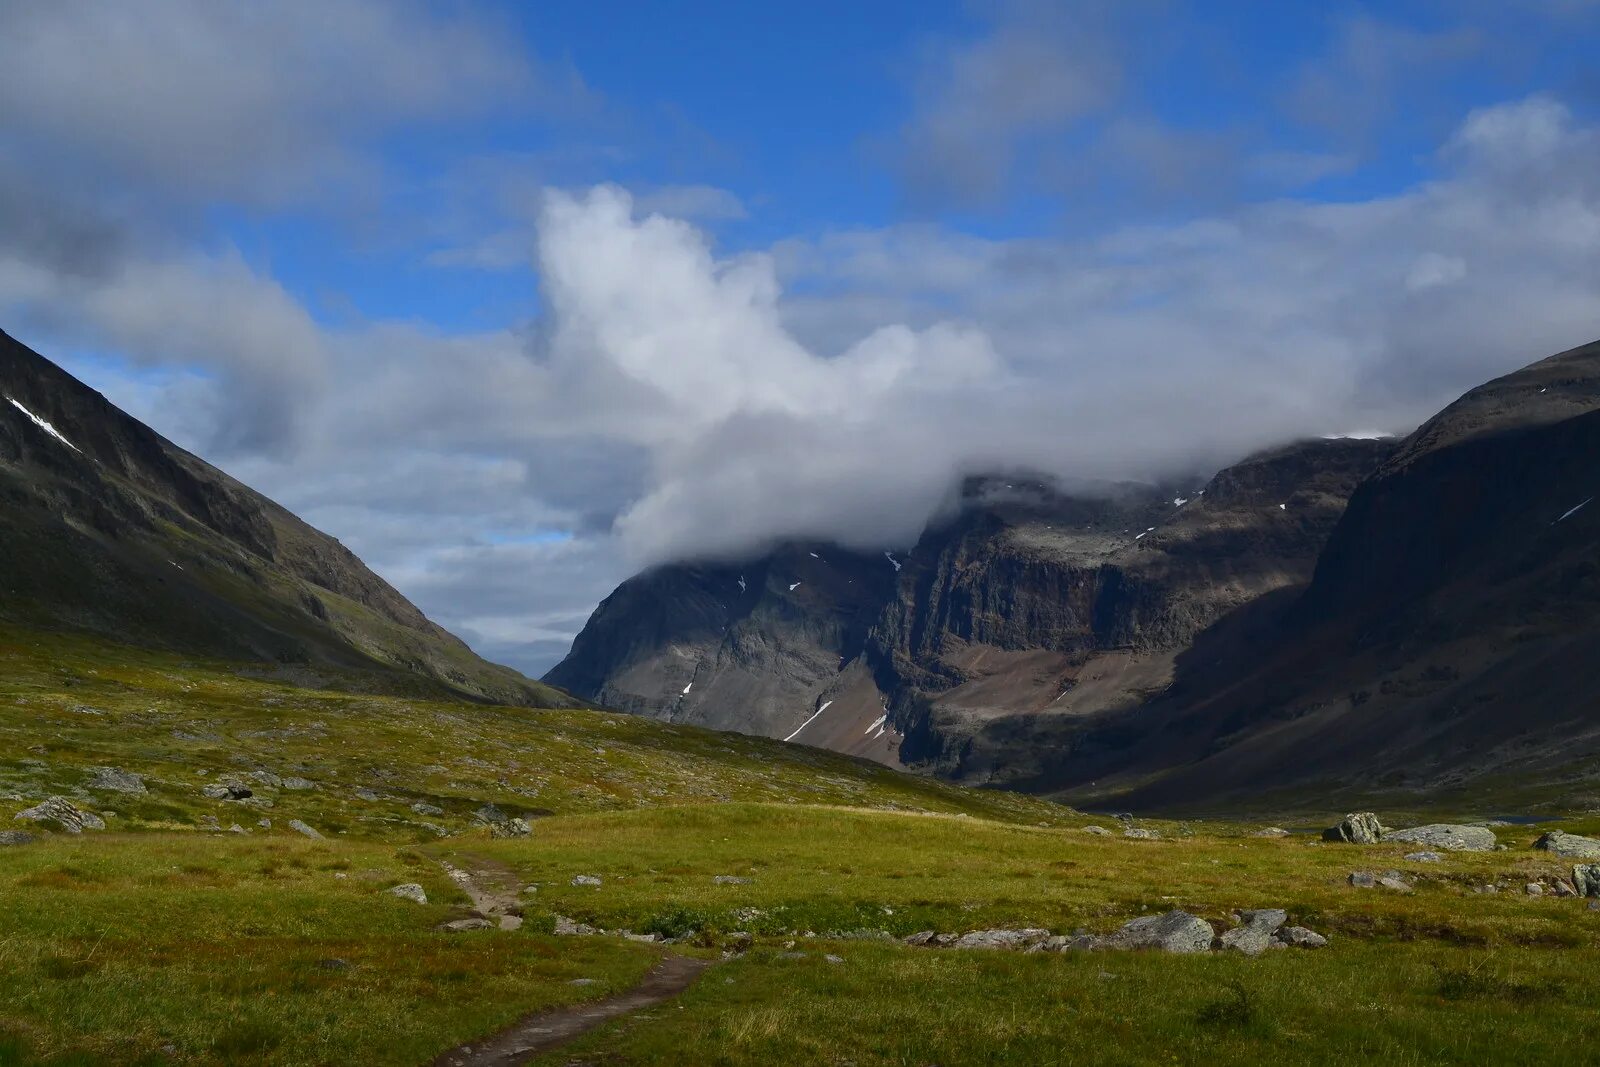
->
[[1035, 337, 1600, 806]]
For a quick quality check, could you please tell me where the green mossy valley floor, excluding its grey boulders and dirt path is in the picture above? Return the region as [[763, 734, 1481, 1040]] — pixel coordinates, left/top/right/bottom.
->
[[0, 632, 1600, 1067]]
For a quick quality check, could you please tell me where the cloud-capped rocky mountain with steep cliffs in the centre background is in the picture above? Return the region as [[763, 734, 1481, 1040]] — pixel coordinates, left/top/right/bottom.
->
[[546, 440, 1392, 771]]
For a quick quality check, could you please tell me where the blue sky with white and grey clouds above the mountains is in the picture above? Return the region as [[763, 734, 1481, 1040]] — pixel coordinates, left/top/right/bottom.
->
[[0, 0, 1600, 673]]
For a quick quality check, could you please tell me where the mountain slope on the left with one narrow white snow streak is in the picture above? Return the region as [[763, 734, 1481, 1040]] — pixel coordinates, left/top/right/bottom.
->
[[0, 333, 573, 705]]
